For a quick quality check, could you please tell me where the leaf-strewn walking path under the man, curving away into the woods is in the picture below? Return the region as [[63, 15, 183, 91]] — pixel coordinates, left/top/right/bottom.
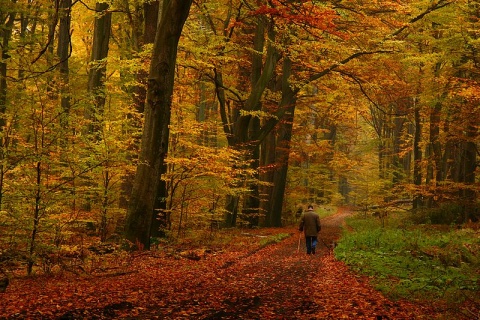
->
[[132, 208, 442, 319]]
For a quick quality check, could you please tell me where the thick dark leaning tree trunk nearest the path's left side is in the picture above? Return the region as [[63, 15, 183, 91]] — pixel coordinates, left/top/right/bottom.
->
[[125, 0, 192, 249]]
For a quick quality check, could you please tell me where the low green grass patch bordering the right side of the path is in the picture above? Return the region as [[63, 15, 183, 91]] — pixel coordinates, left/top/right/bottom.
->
[[335, 213, 480, 302]]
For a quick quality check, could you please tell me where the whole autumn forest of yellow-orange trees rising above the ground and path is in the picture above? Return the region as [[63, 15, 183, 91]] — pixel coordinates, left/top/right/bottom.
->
[[0, 0, 480, 318]]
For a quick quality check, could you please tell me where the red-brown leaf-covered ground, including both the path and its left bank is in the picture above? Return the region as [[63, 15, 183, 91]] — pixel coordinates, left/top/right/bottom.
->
[[0, 209, 468, 319]]
